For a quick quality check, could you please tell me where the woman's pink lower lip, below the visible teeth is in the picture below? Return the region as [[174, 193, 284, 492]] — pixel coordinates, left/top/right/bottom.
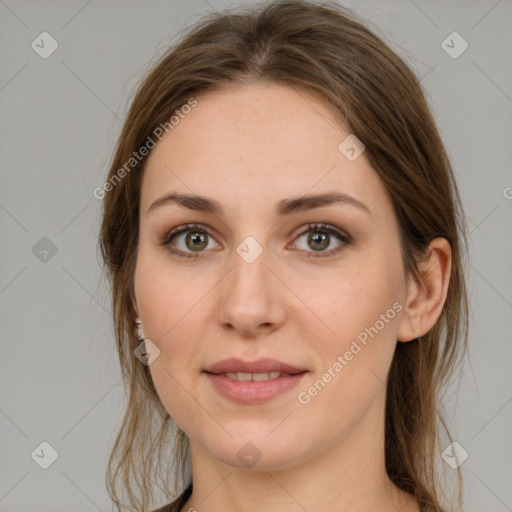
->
[[206, 372, 307, 404]]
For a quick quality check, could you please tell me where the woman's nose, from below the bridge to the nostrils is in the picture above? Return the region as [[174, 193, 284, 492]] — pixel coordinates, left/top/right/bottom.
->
[[217, 246, 286, 338]]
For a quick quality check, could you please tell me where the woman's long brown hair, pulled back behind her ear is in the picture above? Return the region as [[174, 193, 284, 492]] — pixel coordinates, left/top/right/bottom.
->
[[99, 0, 468, 512]]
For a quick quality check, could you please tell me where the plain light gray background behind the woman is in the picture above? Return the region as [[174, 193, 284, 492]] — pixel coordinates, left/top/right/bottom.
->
[[0, 0, 512, 512]]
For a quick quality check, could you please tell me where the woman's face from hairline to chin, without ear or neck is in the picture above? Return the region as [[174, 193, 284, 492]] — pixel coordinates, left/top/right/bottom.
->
[[135, 84, 406, 470]]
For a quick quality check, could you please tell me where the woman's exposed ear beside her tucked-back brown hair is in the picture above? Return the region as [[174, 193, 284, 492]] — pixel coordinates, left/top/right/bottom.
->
[[397, 238, 452, 342]]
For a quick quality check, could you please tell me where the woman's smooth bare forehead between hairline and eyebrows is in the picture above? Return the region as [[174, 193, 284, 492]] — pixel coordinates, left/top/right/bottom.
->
[[141, 83, 383, 219]]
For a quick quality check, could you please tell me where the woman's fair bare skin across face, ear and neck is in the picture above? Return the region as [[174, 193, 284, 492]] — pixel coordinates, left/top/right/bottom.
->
[[134, 84, 451, 512]]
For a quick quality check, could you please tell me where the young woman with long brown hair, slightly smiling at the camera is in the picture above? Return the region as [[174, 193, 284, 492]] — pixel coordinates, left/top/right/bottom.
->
[[100, 1, 468, 512]]
